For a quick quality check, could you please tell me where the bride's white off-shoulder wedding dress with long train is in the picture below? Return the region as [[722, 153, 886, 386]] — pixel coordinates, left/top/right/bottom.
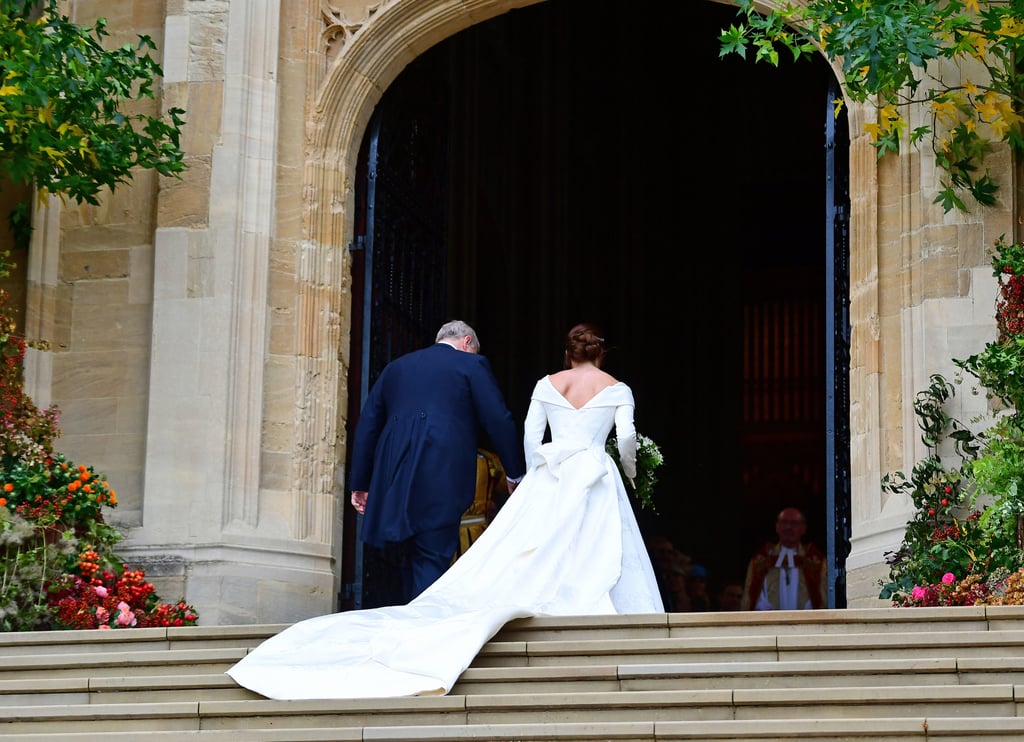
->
[[227, 377, 664, 700]]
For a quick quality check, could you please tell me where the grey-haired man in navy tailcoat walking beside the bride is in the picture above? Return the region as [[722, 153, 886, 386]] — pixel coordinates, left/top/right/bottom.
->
[[348, 320, 526, 603]]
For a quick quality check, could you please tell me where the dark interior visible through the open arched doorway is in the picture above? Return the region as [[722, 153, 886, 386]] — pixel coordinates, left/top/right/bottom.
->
[[344, 0, 847, 605]]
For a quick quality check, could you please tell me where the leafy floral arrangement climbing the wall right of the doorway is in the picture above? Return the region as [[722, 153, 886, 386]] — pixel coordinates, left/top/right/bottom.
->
[[879, 237, 1024, 607]]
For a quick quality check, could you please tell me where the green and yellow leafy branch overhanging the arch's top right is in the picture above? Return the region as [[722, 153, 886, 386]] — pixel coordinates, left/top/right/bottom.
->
[[719, 0, 1024, 212]]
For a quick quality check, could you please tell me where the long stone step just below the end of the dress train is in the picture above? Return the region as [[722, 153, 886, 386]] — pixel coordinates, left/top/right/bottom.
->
[[0, 684, 1020, 740]]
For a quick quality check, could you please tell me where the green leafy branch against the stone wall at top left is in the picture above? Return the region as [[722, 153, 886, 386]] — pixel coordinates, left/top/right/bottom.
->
[[0, 0, 185, 204]]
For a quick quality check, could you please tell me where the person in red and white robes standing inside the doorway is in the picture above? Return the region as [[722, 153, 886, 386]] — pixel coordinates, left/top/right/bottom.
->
[[741, 508, 828, 611]]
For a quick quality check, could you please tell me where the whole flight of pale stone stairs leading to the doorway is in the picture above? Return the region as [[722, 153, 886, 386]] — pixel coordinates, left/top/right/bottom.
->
[[0, 606, 1024, 742]]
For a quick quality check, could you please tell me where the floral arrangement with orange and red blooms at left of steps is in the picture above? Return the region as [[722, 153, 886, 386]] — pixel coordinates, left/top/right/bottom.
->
[[0, 253, 199, 631]]
